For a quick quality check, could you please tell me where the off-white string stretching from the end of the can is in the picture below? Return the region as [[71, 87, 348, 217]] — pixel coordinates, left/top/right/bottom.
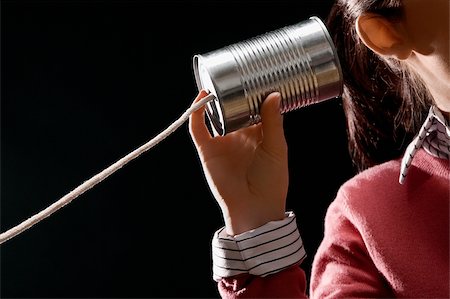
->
[[0, 94, 215, 244]]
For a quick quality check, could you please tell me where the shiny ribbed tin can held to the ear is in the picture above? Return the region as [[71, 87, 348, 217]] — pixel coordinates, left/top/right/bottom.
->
[[193, 17, 343, 136]]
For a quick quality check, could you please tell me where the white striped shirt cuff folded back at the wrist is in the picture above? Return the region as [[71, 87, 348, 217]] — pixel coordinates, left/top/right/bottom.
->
[[212, 212, 306, 281]]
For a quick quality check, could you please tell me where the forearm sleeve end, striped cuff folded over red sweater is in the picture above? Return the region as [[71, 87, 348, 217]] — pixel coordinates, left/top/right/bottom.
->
[[212, 212, 306, 298]]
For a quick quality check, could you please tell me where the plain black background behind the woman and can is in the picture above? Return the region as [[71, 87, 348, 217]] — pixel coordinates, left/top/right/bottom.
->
[[0, 0, 353, 298]]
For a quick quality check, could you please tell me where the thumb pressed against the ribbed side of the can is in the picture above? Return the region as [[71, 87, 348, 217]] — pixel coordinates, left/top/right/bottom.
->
[[261, 92, 286, 152]]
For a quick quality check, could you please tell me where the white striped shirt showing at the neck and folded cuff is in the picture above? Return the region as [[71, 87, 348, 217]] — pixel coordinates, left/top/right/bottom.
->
[[212, 106, 450, 281]]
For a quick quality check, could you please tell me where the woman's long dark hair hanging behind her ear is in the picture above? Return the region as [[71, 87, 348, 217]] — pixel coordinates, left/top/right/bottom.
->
[[326, 0, 431, 171]]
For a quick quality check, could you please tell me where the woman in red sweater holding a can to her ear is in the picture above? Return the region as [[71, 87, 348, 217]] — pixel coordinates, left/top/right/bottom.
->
[[189, 0, 450, 298]]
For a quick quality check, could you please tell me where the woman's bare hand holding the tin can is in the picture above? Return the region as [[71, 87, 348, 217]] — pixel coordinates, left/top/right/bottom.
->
[[189, 91, 288, 235]]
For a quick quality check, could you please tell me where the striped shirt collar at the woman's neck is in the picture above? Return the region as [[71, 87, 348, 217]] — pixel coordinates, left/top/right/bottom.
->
[[399, 106, 450, 184]]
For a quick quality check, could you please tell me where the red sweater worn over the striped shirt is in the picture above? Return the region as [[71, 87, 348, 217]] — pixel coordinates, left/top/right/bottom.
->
[[218, 149, 450, 298]]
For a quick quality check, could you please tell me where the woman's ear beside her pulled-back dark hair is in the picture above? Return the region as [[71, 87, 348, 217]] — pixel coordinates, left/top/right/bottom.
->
[[356, 13, 412, 60]]
